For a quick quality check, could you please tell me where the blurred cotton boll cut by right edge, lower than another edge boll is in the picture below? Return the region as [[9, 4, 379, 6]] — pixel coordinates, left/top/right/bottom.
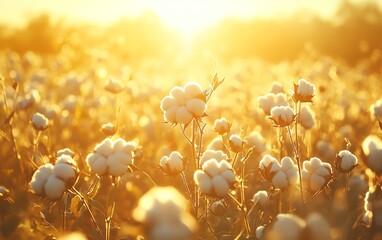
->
[[362, 135, 382, 175]]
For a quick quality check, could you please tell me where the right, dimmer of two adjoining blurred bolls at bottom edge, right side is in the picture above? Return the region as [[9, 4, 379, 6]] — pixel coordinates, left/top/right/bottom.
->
[[306, 213, 332, 240]]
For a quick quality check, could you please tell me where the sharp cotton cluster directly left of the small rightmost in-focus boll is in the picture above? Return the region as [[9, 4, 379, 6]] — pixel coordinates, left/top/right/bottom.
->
[[301, 157, 333, 192]]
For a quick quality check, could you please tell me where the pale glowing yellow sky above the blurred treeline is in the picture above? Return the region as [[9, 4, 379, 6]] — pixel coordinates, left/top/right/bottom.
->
[[0, 0, 382, 34]]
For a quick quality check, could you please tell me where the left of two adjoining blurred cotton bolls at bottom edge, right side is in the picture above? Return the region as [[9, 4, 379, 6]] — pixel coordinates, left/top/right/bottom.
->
[[271, 214, 305, 240]]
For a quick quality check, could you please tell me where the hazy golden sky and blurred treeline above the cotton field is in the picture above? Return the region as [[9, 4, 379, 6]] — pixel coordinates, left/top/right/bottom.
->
[[0, 0, 382, 70]]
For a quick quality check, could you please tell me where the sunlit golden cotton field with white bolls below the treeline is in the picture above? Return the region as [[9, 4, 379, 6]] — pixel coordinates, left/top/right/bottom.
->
[[0, 0, 382, 240]]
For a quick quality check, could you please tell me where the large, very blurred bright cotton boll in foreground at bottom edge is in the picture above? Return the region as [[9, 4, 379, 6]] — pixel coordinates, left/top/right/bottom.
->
[[133, 187, 197, 240]]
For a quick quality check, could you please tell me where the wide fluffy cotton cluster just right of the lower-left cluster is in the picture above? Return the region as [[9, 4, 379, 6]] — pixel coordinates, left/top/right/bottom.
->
[[86, 138, 137, 177]]
